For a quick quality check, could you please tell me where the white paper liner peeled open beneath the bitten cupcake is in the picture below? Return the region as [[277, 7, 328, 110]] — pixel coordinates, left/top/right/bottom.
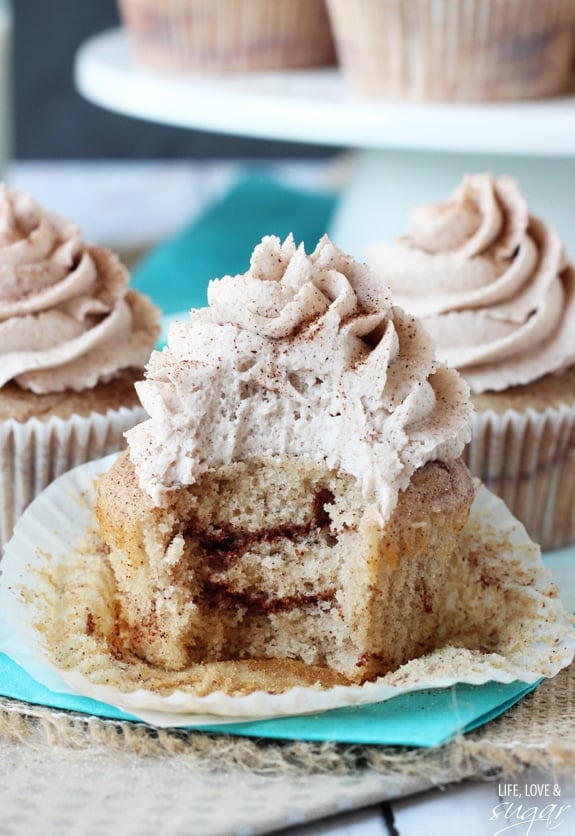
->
[[0, 456, 575, 725]]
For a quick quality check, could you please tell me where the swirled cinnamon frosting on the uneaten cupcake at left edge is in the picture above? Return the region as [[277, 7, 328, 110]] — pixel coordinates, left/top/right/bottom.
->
[[0, 185, 159, 394]]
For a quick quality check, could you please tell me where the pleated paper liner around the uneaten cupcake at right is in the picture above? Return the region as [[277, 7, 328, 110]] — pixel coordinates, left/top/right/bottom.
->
[[464, 404, 575, 549]]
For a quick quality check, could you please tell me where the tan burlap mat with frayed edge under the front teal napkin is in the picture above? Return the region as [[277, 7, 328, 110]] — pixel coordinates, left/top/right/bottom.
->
[[0, 664, 575, 836]]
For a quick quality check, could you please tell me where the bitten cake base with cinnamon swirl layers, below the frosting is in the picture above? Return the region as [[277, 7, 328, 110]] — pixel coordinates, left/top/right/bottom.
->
[[96, 454, 473, 682]]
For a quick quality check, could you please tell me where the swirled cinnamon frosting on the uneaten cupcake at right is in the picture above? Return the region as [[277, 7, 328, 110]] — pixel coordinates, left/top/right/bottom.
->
[[367, 174, 575, 393]]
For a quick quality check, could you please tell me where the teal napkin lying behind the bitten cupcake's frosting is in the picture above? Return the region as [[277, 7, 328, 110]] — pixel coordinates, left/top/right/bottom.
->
[[132, 175, 336, 315]]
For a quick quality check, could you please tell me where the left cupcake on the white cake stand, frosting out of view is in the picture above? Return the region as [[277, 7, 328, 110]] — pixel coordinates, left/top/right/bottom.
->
[[119, 0, 335, 71]]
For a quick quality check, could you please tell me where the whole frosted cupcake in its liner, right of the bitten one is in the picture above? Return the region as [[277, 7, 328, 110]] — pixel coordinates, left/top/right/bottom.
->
[[367, 174, 575, 549]]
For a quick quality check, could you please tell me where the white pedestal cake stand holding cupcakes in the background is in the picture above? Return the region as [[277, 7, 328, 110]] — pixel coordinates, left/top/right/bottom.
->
[[75, 29, 575, 258]]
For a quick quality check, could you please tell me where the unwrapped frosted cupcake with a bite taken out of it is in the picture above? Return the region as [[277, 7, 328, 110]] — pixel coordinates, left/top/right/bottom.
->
[[95, 236, 474, 692]]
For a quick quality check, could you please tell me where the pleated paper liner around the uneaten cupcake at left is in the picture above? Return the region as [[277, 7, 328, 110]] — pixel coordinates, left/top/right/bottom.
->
[[0, 406, 147, 557]]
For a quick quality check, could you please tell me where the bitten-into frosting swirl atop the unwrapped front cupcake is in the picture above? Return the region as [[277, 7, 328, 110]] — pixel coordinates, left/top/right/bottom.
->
[[127, 236, 470, 518]]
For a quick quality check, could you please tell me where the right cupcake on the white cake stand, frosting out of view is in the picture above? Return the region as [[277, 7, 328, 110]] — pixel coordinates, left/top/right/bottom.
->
[[327, 0, 575, 101]]
